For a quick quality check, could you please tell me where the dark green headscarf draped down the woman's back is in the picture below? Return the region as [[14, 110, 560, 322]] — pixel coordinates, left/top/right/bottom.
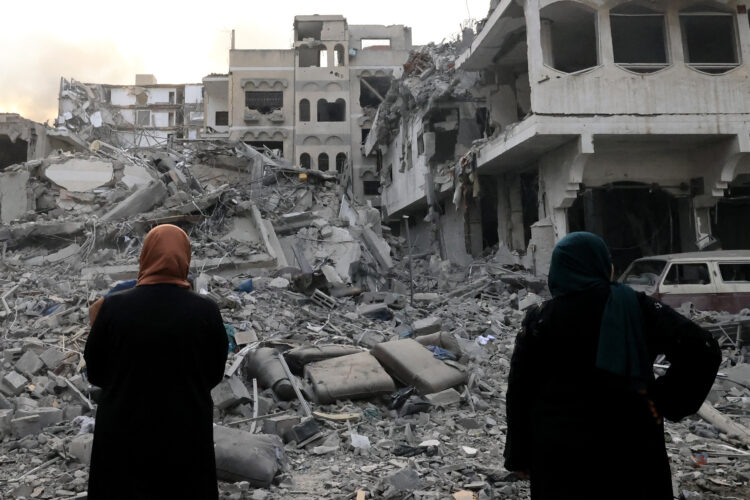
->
[[548, 232, 652, 390]]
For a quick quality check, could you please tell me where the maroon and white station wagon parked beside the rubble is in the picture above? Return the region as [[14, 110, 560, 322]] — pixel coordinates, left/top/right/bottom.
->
[[620, 250, 750, 313]]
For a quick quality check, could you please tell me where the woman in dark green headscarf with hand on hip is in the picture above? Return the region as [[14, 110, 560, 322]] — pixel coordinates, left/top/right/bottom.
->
[[505, 233, 721, 500]]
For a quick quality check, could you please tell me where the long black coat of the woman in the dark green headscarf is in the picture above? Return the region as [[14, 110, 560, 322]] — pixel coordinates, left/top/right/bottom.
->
[[505, 287, 721, 500]]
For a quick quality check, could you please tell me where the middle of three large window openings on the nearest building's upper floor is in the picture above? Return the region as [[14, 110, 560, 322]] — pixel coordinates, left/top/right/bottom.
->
[[609, 3, 669, 73]]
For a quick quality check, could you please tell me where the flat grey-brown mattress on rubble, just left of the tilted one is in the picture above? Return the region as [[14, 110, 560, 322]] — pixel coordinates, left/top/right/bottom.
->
[[305, 351, 400, 404]]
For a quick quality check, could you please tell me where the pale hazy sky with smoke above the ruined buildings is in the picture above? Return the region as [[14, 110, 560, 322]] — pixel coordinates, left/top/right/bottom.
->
[[0, 0, 490, 124]]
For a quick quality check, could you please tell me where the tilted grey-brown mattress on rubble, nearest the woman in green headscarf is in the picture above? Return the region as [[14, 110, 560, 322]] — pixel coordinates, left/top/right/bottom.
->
[[371, 339, 466, 394]]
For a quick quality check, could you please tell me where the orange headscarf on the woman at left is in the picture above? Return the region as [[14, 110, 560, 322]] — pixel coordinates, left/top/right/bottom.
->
[[135, 224, 190, 288]]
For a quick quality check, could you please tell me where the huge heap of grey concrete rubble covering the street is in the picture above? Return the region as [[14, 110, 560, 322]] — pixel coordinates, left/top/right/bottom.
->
[[0, 138, 750, 499]]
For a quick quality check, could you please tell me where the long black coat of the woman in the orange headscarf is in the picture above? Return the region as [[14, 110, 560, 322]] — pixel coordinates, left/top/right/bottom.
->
[[84, 284, 227, 500]]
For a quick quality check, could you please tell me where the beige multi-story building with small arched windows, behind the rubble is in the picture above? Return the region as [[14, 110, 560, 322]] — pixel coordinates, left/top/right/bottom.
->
[[203, 15, 412, 205]]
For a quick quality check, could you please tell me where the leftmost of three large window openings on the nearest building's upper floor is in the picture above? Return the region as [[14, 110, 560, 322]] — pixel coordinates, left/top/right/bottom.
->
[[539, 0, 599, 73]]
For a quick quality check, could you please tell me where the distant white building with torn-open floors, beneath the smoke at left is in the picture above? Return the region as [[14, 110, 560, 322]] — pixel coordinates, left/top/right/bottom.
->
[[56, 74, 203, 148]]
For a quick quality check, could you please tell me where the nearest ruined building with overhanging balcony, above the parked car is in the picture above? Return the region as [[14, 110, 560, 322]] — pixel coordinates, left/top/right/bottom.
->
[[366, 0, 750, 273]]
